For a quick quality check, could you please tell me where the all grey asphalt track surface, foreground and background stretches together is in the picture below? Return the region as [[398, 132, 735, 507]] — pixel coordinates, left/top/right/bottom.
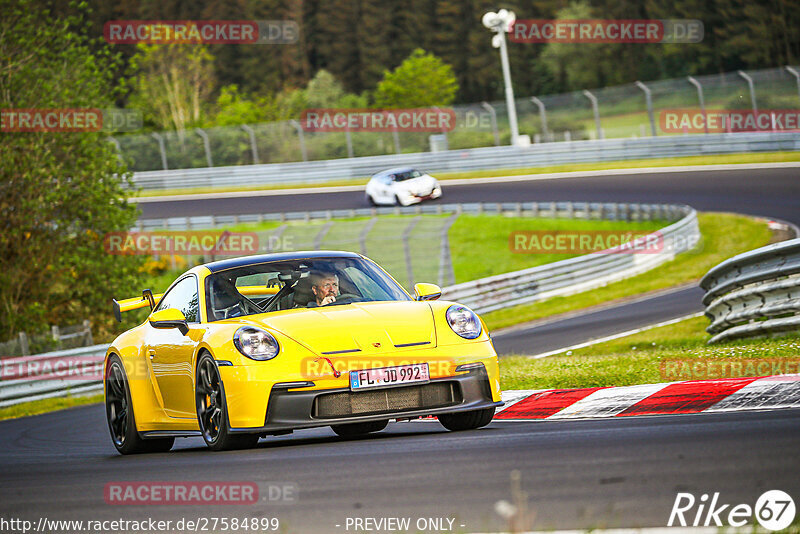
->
[[0, 168, 800, 532]]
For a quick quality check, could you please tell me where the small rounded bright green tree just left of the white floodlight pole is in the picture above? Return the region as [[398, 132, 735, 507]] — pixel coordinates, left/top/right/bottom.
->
[[375, 48, 458, 108]]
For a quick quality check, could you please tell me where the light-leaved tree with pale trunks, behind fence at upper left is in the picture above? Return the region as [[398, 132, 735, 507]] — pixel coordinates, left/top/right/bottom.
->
[[131, 43, 214, 131]]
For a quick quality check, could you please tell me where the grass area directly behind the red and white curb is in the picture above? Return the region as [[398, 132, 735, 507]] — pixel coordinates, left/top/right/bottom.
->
[[500, 317, 800, 390]]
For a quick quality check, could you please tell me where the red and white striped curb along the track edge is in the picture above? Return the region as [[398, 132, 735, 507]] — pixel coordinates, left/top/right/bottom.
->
[[494, 375, 800, 420]]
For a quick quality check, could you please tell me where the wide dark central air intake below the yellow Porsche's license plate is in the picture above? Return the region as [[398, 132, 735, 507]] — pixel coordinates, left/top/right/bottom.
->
[[311, 382, 462, 417]]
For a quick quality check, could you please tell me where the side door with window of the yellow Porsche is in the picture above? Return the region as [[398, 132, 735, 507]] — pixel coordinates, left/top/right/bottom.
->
[[145, 275, 200, 418]]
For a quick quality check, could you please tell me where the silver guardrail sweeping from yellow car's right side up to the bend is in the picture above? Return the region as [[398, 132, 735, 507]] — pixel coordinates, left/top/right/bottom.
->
[[442, 206, 700, 313]]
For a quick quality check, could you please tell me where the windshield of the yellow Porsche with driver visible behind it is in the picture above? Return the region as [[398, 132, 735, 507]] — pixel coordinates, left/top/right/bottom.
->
[[206, 258, 410, 321]]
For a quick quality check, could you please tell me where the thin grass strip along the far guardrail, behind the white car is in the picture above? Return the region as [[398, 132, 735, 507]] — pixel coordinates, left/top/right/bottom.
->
[[133, 151, 800, 202]]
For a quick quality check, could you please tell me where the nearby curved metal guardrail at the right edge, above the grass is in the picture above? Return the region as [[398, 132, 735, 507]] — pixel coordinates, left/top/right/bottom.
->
[[700, 239, 800, 343]]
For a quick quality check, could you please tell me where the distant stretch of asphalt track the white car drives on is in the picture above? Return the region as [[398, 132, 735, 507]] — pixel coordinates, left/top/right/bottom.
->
[[139, 167, 800, 224]]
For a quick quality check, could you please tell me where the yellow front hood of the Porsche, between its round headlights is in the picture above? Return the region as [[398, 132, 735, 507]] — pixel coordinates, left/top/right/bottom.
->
[[253, 301, 436, 355]]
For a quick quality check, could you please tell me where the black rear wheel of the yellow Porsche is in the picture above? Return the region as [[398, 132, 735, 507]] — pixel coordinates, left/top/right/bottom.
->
[[104, 354, 175, 454]]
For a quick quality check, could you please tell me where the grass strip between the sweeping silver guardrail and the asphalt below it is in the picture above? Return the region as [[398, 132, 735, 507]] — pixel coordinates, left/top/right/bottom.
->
[[483, 213, 771, 330]]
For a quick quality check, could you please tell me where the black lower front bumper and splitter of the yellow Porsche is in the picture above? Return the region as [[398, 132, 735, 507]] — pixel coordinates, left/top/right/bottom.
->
[[230, 367, 503, 434]]
